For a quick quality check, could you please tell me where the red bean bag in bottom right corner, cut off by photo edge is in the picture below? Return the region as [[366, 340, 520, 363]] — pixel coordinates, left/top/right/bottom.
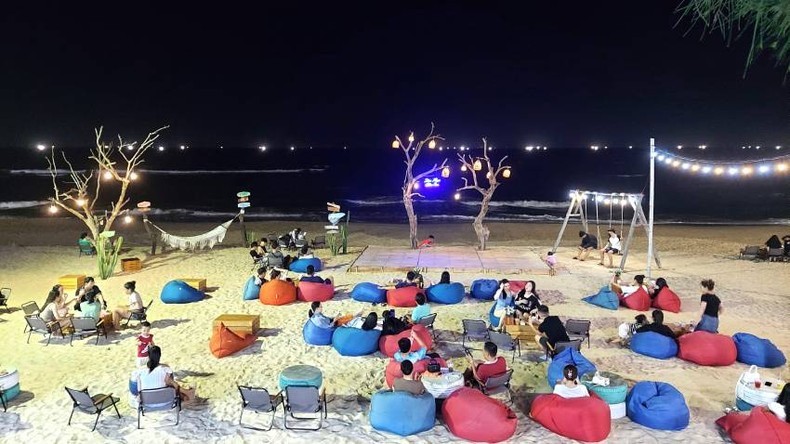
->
[[716, 408, 790, 444]]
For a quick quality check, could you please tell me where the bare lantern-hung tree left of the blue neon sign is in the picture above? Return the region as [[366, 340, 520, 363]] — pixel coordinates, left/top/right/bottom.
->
[[392, 124, 447, 248]]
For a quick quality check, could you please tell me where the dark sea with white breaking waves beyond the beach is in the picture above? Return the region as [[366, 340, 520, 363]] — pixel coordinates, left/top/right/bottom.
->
[[0, 145, 790, 225]]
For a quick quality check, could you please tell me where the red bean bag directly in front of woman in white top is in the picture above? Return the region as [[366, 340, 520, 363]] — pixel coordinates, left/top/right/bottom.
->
[[529, 394, 612, 442]]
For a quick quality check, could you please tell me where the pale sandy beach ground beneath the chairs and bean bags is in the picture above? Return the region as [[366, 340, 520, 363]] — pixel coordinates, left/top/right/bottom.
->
[[0, 218, 790, 443]]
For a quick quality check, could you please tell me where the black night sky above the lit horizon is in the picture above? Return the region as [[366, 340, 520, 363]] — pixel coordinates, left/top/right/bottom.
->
[[0, 0, 790, 148]]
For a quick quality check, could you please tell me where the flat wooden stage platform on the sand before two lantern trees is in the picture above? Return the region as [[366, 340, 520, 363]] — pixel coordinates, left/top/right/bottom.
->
[[348, 245, 560, 274]]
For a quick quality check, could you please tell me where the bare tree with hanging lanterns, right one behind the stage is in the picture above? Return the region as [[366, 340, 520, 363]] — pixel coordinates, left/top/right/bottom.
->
[[456, 137, 510, 250]]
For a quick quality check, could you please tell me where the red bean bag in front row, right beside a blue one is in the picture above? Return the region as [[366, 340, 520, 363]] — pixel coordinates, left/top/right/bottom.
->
[[442, 387, 518, 442]]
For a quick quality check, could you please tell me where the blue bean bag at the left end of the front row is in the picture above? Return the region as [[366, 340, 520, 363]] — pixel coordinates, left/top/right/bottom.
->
[[368, 391, 436, 436]]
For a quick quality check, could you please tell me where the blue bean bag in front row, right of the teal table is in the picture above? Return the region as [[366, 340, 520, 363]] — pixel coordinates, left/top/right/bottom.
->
[[625, 381, 689, 430]]
